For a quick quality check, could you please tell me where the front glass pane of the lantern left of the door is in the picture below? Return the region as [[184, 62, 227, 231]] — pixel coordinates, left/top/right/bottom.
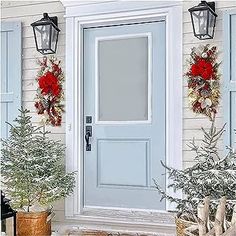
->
[[35, 25, 50, 52]]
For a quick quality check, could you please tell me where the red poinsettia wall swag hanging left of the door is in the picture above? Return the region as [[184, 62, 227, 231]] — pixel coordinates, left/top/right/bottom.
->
[[35, 57, 64, 126]]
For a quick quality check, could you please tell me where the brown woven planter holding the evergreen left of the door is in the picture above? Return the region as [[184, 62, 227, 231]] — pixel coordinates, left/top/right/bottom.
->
[[16, 211, 51, 236]]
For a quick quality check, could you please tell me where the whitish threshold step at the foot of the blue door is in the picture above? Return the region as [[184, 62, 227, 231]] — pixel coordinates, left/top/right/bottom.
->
[[61, 208, 176, 236]]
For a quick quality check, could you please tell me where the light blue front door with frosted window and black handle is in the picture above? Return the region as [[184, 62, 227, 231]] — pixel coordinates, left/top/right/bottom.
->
[[84, 20, 166, 210]]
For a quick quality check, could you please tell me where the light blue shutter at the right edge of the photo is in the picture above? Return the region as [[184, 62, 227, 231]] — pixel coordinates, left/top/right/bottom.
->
[[223, 10, 236, 148]]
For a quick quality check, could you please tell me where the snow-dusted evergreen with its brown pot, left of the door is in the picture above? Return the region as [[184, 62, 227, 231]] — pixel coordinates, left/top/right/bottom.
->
[[1, 109, 75, 236]]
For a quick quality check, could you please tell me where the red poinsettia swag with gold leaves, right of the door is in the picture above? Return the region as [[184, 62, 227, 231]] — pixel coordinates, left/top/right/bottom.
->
[[186, 44, 220, 120]]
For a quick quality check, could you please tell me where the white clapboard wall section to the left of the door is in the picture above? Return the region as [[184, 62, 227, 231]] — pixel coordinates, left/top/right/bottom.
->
[[1, 1, 65, 225]]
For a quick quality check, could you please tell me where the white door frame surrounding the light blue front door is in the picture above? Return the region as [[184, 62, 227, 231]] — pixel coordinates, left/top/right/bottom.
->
[[62, 0, 182, 232]]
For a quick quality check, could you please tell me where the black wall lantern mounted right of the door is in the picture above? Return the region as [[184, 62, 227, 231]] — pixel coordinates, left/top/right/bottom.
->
[[188, 1, 217, 40]]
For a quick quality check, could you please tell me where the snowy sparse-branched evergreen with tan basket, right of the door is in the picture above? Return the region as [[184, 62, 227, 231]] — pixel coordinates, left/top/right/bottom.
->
[[154, 120, 236, 236]]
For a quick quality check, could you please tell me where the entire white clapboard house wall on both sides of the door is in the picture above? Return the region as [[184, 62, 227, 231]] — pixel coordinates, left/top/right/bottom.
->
[[1, 1, 236, 229]]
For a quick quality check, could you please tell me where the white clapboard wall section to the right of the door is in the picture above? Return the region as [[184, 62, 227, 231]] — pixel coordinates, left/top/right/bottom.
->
[[183, 0, 236, 170]]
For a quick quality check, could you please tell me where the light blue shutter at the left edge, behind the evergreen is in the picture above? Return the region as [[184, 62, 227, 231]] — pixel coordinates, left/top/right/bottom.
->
[[1, 22, 21, 138]]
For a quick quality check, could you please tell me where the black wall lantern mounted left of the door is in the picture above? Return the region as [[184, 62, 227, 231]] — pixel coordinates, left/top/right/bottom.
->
[[31, 13, 60, 55]]
